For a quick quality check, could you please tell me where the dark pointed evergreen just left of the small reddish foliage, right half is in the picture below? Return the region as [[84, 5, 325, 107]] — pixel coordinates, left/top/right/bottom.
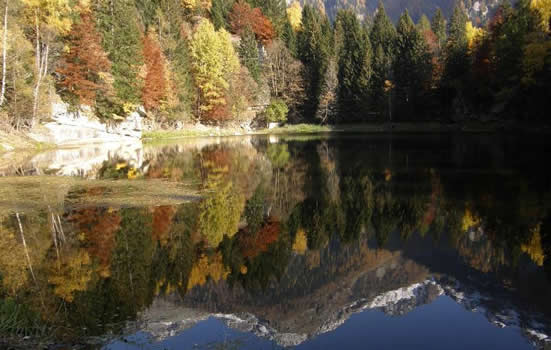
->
[[394, 10, 431, 115]]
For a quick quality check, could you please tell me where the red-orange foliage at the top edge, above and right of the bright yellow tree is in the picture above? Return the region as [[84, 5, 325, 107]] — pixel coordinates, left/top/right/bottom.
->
[[229, 1, 275, 45]]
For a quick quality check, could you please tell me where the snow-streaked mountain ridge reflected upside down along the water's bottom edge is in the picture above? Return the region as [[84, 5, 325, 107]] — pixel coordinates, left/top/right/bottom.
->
[[135, 279, 551, 347]]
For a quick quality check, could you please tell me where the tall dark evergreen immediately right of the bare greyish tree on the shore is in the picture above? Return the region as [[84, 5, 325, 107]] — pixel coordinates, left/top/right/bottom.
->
[[336, 10, 371, 120]]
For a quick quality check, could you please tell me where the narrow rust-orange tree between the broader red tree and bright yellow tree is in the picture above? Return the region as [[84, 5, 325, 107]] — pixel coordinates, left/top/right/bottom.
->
[[142, 33, 168, 111]]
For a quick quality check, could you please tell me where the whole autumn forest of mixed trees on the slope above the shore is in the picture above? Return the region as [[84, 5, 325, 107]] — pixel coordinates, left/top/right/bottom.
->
[[0, 0, 551, 130]]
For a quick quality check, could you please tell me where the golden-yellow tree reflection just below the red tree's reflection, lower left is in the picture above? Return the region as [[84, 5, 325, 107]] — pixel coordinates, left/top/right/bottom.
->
[[48, 250, 92, 302]]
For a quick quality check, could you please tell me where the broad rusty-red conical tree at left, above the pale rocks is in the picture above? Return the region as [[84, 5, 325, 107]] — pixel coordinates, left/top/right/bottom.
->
[[57, 10, 111, 105]]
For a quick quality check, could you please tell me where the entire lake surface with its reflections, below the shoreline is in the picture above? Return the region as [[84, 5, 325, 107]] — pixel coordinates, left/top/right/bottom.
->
[[0, 134, 551, 349]]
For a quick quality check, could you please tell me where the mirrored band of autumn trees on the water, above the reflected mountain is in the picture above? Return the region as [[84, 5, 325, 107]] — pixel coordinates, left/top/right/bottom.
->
[[0, 137, 551, 340]]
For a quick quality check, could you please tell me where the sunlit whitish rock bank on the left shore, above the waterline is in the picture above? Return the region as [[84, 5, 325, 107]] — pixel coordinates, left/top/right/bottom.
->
[[29, 103, 144, 146]]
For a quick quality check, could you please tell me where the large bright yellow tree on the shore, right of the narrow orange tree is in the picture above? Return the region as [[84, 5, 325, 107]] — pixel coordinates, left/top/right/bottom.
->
[[190, 20, 239, 120]]
